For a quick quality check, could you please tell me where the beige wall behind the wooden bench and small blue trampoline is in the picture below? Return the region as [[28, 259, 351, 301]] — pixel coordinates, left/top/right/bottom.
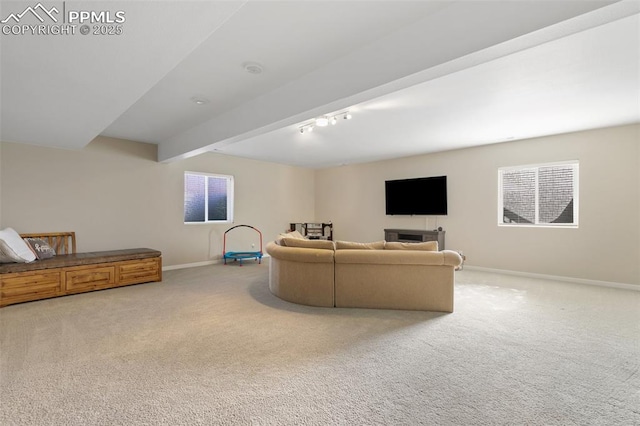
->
[[0, 137, 314, 266]]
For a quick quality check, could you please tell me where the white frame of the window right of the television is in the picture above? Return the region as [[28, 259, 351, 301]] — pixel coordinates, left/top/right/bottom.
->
[[498, 160, 580, 228]]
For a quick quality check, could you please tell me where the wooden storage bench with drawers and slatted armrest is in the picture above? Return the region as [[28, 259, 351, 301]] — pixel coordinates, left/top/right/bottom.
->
[[0, 232, 162, 307]]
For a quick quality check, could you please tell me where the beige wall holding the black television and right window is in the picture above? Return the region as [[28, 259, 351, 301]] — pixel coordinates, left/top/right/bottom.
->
[[315, 125, 640, 284]]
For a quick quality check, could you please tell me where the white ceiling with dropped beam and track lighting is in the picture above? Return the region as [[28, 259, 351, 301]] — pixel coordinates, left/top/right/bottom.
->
[[0, 0, 640, 168]]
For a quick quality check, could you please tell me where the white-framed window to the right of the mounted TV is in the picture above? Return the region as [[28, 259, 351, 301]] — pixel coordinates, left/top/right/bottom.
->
[[498, 161, 578, 227]]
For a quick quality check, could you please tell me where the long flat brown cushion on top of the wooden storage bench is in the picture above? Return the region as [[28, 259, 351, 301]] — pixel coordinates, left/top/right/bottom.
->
[[0, 248, 162, 274]]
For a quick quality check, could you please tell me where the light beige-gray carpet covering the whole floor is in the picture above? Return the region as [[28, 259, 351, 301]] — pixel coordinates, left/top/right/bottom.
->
[[0, 260, 640, 425]]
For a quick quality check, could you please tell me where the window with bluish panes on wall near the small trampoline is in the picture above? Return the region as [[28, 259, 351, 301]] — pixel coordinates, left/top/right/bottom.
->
[[184, 172, 233, 223]]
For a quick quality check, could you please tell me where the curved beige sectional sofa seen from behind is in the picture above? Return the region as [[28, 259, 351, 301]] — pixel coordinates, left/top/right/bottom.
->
[[266, 237, 462, 312]]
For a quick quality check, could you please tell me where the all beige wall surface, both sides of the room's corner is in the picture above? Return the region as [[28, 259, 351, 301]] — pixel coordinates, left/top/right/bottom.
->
[[0, 125, 640, 284]]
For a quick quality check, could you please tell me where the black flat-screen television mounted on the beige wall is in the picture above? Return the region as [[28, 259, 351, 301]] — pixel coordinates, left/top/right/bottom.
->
[[385, 176, 447, 216]]
